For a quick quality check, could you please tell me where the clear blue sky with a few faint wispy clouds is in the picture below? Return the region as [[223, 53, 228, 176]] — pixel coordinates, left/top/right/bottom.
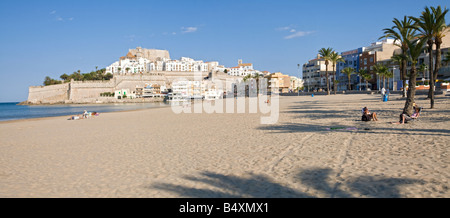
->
[[0, 0, 448, 102]]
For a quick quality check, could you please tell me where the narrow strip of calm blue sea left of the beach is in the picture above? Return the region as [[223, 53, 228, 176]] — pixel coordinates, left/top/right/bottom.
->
[[0, 102, 167, 121]]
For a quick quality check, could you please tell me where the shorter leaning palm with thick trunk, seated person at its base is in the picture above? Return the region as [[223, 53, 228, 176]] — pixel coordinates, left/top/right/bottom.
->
[[403, 39, 426, 115]]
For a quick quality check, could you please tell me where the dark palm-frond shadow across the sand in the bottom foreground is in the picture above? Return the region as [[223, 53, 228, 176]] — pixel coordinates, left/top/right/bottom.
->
[[148, 168, 424, 198]]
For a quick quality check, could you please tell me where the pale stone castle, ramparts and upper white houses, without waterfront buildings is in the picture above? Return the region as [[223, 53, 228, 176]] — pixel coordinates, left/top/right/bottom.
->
[[26, 47, 240, 104]]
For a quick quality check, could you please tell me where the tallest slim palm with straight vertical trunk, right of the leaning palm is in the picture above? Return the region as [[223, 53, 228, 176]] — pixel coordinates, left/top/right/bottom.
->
[[410, 7, 436, 108]]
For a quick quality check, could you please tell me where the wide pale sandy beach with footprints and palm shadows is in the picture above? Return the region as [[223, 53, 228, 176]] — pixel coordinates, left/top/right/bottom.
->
[[0, 94, 450, 198]]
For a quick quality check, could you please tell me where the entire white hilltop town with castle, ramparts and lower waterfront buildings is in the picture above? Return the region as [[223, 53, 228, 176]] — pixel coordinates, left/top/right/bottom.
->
[[23, 47, 303, 104]]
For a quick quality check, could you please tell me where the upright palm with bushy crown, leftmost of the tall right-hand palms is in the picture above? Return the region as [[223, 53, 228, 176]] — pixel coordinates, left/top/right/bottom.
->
[[380, 16, 416, 97]]
